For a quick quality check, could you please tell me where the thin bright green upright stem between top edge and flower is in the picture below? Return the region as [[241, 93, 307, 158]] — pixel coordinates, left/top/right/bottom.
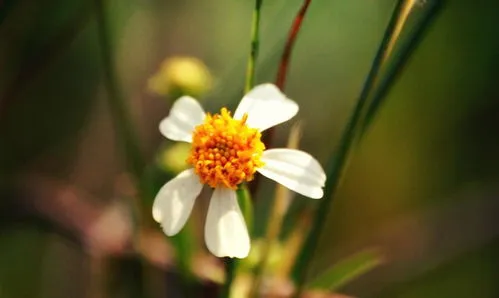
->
[[244, 0, 263, 93]]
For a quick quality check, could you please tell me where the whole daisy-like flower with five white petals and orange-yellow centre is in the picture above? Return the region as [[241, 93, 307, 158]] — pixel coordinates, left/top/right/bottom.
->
[[152, 84, 326, 258]]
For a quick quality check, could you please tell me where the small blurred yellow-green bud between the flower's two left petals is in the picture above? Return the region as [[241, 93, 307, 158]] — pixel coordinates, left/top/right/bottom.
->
[[158, 142, 191, 173]]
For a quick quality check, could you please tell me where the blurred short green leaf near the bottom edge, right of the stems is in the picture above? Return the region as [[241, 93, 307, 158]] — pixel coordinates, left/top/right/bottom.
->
[[307, 249, 383, 291]]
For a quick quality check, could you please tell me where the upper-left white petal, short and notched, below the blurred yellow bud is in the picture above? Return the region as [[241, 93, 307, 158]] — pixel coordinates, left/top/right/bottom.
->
[[159, 96, 205, 143]]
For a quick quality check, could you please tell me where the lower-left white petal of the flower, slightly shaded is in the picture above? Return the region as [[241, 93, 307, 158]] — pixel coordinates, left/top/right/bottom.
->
[[152, 169, 203, 236]]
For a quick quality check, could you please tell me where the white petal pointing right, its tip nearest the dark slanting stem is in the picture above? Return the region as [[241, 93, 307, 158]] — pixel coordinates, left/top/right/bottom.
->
[[257, 149, 326, 199]]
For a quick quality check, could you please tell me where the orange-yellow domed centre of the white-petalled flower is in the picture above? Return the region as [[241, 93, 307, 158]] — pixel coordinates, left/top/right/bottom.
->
[[187, 108, 265, 189]]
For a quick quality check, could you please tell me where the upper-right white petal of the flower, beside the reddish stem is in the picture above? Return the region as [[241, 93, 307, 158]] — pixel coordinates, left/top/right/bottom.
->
[[234, 84, 298, 131]]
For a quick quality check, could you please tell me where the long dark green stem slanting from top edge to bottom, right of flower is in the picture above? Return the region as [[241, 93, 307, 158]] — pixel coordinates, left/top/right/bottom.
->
[[292, 0, 422, 297]]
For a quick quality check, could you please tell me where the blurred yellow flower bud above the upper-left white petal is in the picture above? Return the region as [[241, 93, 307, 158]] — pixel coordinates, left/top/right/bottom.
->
[[147, 57, 212, 97]]
